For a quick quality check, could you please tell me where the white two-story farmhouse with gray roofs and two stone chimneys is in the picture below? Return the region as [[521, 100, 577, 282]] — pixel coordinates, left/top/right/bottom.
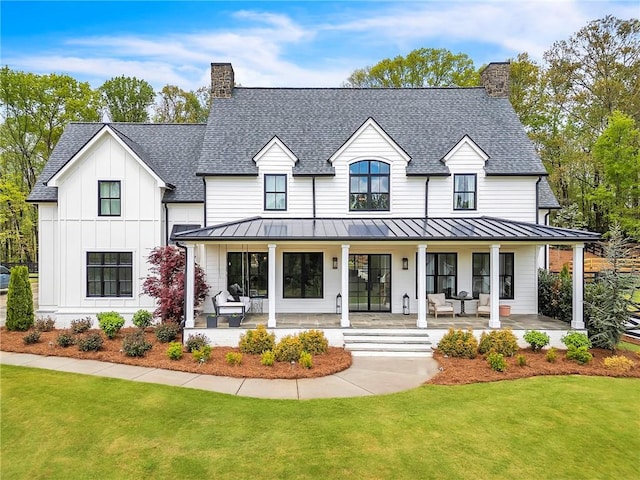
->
[[30, 63, 599, 350]]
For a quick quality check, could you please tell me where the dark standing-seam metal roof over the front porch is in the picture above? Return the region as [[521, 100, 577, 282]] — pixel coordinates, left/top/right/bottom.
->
[[171, 217, 600, 243]]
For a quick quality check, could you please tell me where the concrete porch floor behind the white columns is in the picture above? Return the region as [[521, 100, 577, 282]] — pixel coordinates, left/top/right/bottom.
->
[[195, 312, 571, 330]]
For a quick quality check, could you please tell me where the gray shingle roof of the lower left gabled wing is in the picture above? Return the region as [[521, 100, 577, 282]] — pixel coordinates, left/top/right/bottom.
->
[[29, 123, 205, 202]]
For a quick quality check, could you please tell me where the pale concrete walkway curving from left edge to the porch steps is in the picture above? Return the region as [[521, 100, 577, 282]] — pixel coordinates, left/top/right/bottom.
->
[[0, 351, 438, 400]]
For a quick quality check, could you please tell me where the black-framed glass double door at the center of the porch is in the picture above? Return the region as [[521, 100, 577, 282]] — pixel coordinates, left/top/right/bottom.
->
[[349, 254, 391, 312]]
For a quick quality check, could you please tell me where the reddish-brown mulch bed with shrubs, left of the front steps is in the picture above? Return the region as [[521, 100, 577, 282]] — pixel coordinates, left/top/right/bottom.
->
[[0, 327, 351, 378]]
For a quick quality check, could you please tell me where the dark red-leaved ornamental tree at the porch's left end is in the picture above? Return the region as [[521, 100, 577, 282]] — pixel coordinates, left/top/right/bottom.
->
[[142, 245, 209, 323]]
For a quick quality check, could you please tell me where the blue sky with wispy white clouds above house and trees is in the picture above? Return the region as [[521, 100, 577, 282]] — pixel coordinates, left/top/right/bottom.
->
[[0, 0, 640, 90]]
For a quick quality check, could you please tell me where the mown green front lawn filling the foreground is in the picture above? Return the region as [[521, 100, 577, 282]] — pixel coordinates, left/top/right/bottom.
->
[[0, 365, 640, 479]]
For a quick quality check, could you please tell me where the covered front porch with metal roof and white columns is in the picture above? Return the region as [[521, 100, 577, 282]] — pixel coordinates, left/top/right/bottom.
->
[[172, 217, 599, 342]]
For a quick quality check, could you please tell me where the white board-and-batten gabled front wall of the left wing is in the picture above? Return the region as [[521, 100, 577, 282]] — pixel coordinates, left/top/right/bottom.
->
[[41, 135, 164, 322]]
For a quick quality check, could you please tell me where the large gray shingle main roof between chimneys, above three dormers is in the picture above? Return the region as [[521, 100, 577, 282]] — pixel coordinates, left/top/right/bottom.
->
[[197, 88, 546, 175]]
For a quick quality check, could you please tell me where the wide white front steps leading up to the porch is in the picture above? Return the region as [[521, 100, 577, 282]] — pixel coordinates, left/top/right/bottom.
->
[[343, 328, 433, 357]]
